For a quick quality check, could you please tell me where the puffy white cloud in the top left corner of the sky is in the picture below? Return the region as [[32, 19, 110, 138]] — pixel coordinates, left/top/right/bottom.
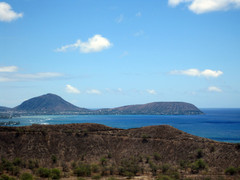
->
[[0, 2, 23, 22]]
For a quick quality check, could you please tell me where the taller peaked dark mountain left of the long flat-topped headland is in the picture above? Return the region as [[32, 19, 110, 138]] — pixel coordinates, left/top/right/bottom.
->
[[14, 94, 89, 114]]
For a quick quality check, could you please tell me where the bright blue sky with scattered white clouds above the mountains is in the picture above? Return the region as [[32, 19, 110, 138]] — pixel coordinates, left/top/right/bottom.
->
[[0, 0, 240, 108]]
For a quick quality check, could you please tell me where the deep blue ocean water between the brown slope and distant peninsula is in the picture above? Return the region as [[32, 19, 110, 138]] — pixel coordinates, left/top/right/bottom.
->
[[0, 109, 240, 143]]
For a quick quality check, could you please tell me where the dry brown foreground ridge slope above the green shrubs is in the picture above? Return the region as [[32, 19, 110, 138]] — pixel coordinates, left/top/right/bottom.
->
[[0, 124, 240, 179]]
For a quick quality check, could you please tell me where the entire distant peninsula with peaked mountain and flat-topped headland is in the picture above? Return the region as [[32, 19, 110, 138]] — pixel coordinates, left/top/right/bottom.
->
[[0, 94, 203, 117]]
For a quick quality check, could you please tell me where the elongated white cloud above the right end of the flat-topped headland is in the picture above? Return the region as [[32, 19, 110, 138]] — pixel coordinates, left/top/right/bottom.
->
[[170, 69, 223, 78]]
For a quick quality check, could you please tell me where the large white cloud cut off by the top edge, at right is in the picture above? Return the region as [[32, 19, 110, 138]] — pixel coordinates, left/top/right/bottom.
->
[[168, 0, 240, 14]]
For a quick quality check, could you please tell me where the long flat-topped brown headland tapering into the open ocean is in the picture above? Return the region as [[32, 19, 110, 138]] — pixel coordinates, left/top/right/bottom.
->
[[95, 102, 203, 115]]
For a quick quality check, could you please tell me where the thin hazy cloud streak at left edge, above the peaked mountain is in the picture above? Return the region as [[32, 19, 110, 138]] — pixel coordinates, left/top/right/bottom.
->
[[0, 72, 63, 82]]
